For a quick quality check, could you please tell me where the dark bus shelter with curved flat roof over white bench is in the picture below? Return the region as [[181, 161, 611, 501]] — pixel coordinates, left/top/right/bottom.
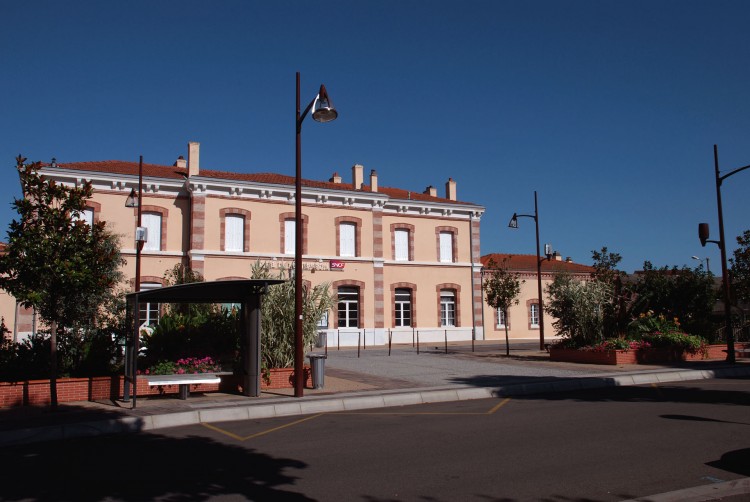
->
[[123, 279, 285, 408]]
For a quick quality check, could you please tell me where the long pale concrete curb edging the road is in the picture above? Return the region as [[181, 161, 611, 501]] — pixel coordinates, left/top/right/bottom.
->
[[0, 367, 750, 446]]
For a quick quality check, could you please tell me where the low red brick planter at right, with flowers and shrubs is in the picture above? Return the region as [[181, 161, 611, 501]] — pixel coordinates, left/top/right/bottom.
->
[[549, 343, 750, 366]]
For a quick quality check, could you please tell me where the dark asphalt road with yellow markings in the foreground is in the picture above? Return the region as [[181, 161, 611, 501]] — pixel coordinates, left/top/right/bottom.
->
[[0, 378, 750, 501]]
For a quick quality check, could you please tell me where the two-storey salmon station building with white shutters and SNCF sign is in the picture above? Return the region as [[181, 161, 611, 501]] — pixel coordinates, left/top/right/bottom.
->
[[10, 142, 485, 345]]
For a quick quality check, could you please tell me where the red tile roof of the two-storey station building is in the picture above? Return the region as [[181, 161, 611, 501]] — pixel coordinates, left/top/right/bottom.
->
[[43, 160, 473, 205]]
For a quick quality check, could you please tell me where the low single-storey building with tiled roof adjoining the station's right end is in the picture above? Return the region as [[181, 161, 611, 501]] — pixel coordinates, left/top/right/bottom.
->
[[482, 253, 594, 340]]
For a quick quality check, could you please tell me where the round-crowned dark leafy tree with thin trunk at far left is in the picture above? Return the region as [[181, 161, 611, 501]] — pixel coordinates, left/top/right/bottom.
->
[[0, 155, 123, 408]]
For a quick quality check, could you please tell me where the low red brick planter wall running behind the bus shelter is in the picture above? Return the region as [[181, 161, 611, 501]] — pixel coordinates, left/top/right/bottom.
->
[[0, 366, 312, 408]]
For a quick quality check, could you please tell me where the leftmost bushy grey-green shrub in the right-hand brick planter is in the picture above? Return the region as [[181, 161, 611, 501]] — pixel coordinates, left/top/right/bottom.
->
[[547, 273, 612, 348]]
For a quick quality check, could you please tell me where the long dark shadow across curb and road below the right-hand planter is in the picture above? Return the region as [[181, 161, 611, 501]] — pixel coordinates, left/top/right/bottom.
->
[[451, 375, 750, 406]]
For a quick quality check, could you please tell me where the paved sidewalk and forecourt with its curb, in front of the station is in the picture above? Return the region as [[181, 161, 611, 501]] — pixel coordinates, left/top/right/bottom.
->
[[0, 342, 750, 445]]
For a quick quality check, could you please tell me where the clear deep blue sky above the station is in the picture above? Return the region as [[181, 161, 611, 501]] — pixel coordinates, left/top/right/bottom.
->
[[0, 0, 750, 273]]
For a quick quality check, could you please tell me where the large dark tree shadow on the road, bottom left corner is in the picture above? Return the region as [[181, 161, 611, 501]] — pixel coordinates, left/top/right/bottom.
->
[[0, 433, 312, 502]]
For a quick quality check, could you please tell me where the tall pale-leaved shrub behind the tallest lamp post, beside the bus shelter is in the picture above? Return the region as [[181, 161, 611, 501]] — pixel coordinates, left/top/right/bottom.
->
[[251, 262, 335, 368]]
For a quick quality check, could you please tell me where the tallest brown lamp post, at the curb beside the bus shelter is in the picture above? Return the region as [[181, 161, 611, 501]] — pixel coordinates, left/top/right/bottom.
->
[[294, 72, 339, 397]]
